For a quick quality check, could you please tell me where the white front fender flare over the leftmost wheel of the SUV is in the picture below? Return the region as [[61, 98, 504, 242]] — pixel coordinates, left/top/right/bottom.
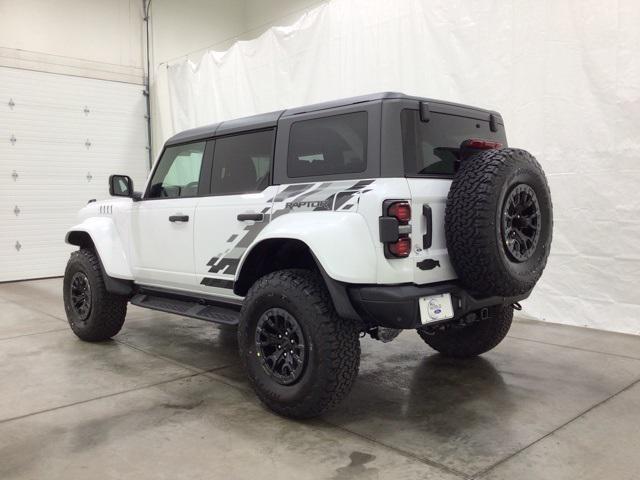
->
[[65, 217, 133, 280]]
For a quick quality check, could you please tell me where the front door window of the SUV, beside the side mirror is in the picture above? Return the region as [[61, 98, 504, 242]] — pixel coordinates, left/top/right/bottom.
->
[[147, 142, 205, 198]]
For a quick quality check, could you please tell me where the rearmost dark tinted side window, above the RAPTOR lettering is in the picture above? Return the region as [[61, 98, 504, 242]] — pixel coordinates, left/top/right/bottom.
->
[[287, 112, 367, 177]]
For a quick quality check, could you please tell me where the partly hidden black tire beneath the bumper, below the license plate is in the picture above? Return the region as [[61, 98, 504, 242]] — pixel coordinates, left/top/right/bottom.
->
[[418, 305, 513, 358]]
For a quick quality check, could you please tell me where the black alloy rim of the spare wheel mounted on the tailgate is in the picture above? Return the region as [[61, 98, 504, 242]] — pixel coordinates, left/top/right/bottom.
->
[[502, 183, 541, 262]]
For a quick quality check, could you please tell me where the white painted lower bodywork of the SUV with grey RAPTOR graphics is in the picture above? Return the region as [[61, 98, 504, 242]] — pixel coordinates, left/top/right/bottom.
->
[[66, 178, 455, 292]]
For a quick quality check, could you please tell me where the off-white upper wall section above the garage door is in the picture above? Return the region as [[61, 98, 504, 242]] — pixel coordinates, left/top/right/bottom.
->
[[0, 0, 144, 84]]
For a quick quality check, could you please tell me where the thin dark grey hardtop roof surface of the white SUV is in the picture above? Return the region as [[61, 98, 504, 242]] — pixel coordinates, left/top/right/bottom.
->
[[165, 92, 502, 145]]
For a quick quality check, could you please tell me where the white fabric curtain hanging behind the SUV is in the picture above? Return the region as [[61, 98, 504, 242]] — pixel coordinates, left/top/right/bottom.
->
[[158, 0, 640, 334]]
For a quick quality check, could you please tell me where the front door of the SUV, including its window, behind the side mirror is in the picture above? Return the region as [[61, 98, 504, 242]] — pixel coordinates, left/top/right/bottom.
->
[[131, 142, 206, 290]]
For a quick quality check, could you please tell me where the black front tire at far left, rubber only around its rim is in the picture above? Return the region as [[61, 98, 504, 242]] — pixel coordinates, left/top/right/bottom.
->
[[63, 248, 128, 342]]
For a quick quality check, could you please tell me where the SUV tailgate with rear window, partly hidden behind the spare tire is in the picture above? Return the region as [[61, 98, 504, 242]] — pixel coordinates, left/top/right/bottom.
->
[[400, 104, 506, 284]]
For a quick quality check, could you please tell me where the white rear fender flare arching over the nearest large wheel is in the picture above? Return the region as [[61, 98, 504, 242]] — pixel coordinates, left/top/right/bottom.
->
[[238, 212, 376, 283]]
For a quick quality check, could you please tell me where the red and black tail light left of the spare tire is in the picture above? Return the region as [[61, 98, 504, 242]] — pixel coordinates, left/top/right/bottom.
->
[[379, 200, 411, 258]]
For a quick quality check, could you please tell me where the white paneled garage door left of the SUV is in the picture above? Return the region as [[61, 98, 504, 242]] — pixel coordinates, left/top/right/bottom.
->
[[0, 67, 148, 281]]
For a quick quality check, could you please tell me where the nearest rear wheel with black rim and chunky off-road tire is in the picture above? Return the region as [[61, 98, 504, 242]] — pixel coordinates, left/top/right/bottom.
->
[[238, 270, 360, 418]]
